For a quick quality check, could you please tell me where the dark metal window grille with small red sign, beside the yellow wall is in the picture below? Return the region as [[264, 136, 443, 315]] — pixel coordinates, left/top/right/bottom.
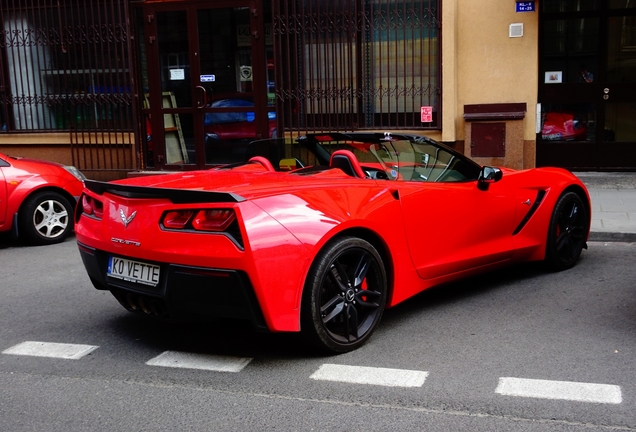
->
[[272, 0, 441, 131]]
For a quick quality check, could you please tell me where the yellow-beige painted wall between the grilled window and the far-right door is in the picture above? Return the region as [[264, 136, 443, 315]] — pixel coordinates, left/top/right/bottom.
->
[[442, 0, 539, 141]]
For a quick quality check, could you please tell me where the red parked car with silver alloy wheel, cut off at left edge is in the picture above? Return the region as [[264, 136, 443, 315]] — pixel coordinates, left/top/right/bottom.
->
[[0, 153, 85, 245]]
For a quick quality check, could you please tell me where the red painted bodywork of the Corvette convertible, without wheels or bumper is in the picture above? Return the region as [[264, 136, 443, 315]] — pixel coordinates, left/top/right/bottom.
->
[[75, 133, 589, 331]]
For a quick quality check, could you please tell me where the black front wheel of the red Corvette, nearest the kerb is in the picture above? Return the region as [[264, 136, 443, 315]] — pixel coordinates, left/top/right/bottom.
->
[[546, 192, 590, 271]]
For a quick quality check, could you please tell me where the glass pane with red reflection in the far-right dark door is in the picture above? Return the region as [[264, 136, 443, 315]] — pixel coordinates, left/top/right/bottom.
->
[[541, 104, 596, 142]]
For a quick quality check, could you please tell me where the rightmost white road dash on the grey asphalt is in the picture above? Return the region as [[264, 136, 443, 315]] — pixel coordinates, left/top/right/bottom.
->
[[495, 378, 623, 404]]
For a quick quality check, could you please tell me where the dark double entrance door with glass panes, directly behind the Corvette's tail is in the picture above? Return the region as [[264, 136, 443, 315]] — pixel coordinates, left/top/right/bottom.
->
[[137, 0, 276, 170]]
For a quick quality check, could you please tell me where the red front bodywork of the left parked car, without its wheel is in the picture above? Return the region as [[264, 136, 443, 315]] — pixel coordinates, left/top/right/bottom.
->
[[0, 153, 84, 231]]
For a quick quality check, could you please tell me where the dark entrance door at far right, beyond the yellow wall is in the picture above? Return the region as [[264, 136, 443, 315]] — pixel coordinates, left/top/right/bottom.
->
[[537, 0, 636, 170]]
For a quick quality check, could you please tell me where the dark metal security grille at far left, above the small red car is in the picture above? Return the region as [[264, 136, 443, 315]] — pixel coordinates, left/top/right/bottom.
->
[[0, 0, 134, 177]]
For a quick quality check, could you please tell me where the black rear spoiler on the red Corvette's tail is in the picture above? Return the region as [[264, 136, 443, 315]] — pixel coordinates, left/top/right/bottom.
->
[[84, 180, 245, 204]]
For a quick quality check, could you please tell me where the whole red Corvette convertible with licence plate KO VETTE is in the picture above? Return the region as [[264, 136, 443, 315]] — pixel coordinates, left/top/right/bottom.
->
[[75, 133, 590, 352]]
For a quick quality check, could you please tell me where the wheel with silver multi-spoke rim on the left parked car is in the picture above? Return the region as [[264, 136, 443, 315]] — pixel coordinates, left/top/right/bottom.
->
[[18, 191, 73, 245]]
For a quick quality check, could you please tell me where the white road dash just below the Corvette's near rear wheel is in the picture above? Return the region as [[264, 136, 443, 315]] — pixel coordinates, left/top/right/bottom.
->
[[309, 364, 428, 387]]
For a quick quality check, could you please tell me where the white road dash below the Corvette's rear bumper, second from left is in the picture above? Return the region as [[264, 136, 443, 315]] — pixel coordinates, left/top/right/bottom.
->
[[146, 351, 252, 372]]
